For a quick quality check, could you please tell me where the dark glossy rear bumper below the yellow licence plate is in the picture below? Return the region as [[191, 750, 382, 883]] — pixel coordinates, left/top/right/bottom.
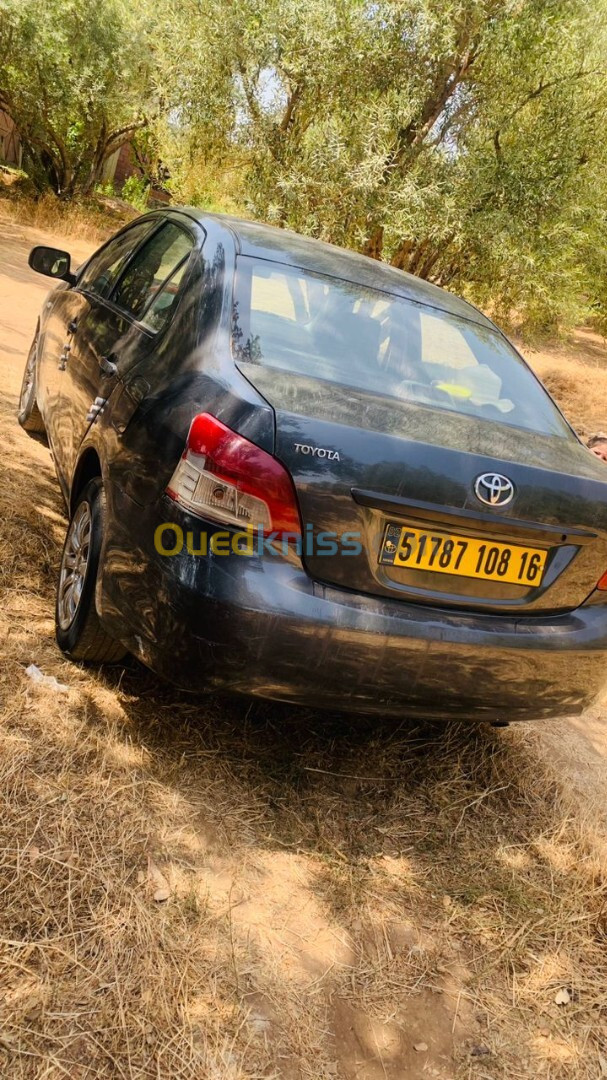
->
[[97, 497, 607, 720]]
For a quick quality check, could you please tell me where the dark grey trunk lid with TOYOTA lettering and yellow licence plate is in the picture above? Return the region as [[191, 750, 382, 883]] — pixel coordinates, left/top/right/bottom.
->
[[239, 363, 607, 613]]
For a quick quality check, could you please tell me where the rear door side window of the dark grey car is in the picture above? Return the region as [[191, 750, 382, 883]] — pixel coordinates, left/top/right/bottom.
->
[[111, 222, 193, 329]]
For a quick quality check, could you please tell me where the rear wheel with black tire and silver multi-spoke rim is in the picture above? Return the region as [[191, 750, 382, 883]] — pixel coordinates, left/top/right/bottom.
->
[[55, 477, 126, 664]]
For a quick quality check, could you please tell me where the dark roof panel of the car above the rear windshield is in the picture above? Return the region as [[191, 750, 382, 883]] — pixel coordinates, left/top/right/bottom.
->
[[172, 206, 495, 328]]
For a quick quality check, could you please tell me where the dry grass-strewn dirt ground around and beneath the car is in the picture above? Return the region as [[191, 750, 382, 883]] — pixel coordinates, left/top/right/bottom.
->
[[0, 218, 607, 1080]]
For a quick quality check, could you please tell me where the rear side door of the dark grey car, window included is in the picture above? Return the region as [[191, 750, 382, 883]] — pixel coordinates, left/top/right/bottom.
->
[[56, 218, 195, 485]]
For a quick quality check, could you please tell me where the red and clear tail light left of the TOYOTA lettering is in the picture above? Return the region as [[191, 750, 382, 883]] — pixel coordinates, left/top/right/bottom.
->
[[166, 413, 301, 540]]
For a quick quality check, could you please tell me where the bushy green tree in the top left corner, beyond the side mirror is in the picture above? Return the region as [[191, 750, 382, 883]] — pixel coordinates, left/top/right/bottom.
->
[[0, 0, 154, 198]]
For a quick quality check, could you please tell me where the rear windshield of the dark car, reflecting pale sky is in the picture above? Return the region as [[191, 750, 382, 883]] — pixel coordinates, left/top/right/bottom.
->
[[232, 256, 570, 435]]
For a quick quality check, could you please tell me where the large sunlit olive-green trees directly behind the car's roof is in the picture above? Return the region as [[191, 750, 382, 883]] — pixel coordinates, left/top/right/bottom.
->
[[154, 0, 607, 332]]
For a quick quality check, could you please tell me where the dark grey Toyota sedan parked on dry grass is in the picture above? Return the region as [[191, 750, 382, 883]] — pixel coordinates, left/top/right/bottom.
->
[[19, 210, 607, 721]]
